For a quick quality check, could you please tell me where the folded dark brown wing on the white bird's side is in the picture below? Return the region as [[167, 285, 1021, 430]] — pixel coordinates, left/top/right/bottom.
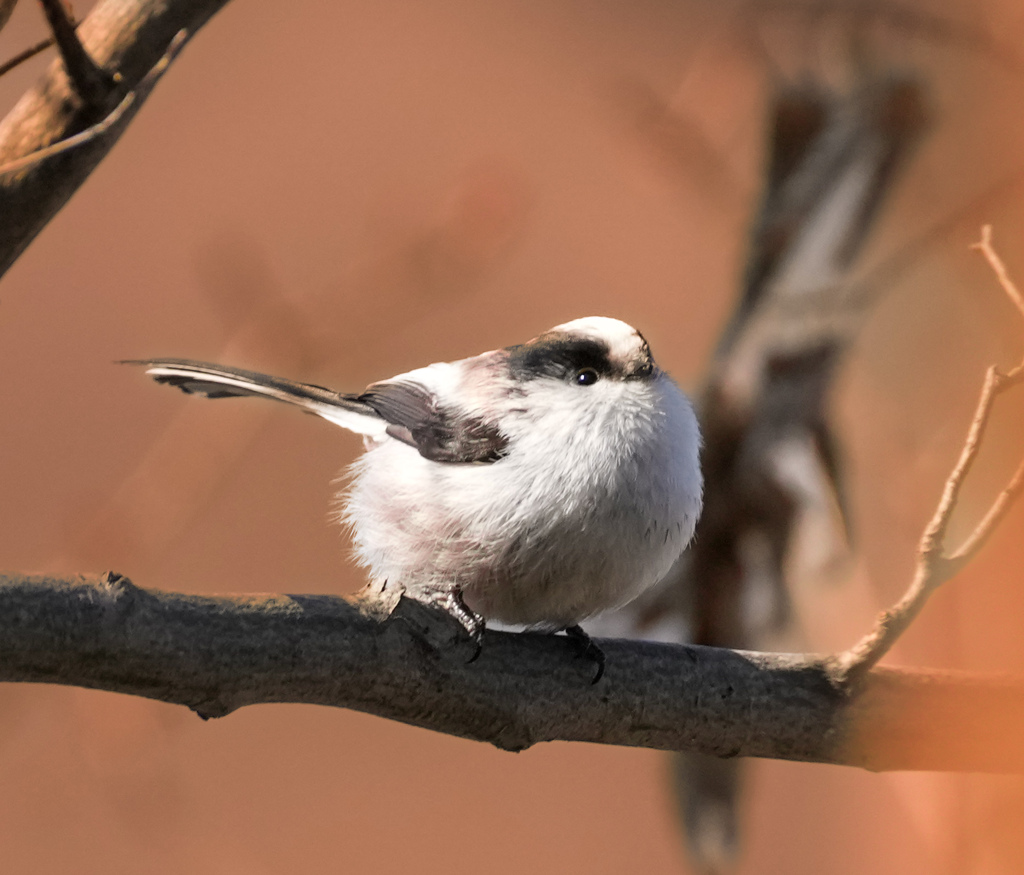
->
[[358, 377, 508, 462]]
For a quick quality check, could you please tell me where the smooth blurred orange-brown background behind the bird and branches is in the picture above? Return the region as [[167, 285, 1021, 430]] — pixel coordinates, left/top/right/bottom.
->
[[0, 0, 1024, 875]]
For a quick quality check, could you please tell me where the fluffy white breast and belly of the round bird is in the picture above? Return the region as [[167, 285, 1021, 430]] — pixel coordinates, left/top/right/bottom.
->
[[341, 375, 701, 628]]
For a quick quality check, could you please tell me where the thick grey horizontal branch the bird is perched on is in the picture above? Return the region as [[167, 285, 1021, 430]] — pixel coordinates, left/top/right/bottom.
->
[[0, 574, 1024, 773]]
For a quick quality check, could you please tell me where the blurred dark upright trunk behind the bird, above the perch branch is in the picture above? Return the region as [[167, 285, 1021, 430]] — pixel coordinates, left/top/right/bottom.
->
[[680, 75, 928, 672]]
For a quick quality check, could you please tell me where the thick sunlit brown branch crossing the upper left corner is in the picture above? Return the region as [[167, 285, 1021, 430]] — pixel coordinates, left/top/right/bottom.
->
[[0, 0, 233, 276]]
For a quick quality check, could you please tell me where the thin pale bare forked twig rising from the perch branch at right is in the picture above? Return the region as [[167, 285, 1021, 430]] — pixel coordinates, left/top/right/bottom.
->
[[835, 225, 1024, 685]]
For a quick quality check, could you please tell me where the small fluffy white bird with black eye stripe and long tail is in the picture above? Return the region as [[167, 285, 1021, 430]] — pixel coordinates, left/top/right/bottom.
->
[[126, 317, 702, 682]]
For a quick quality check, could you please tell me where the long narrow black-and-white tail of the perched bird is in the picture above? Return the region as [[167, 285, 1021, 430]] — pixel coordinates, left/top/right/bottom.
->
[[123, 359, 388, 436]]
